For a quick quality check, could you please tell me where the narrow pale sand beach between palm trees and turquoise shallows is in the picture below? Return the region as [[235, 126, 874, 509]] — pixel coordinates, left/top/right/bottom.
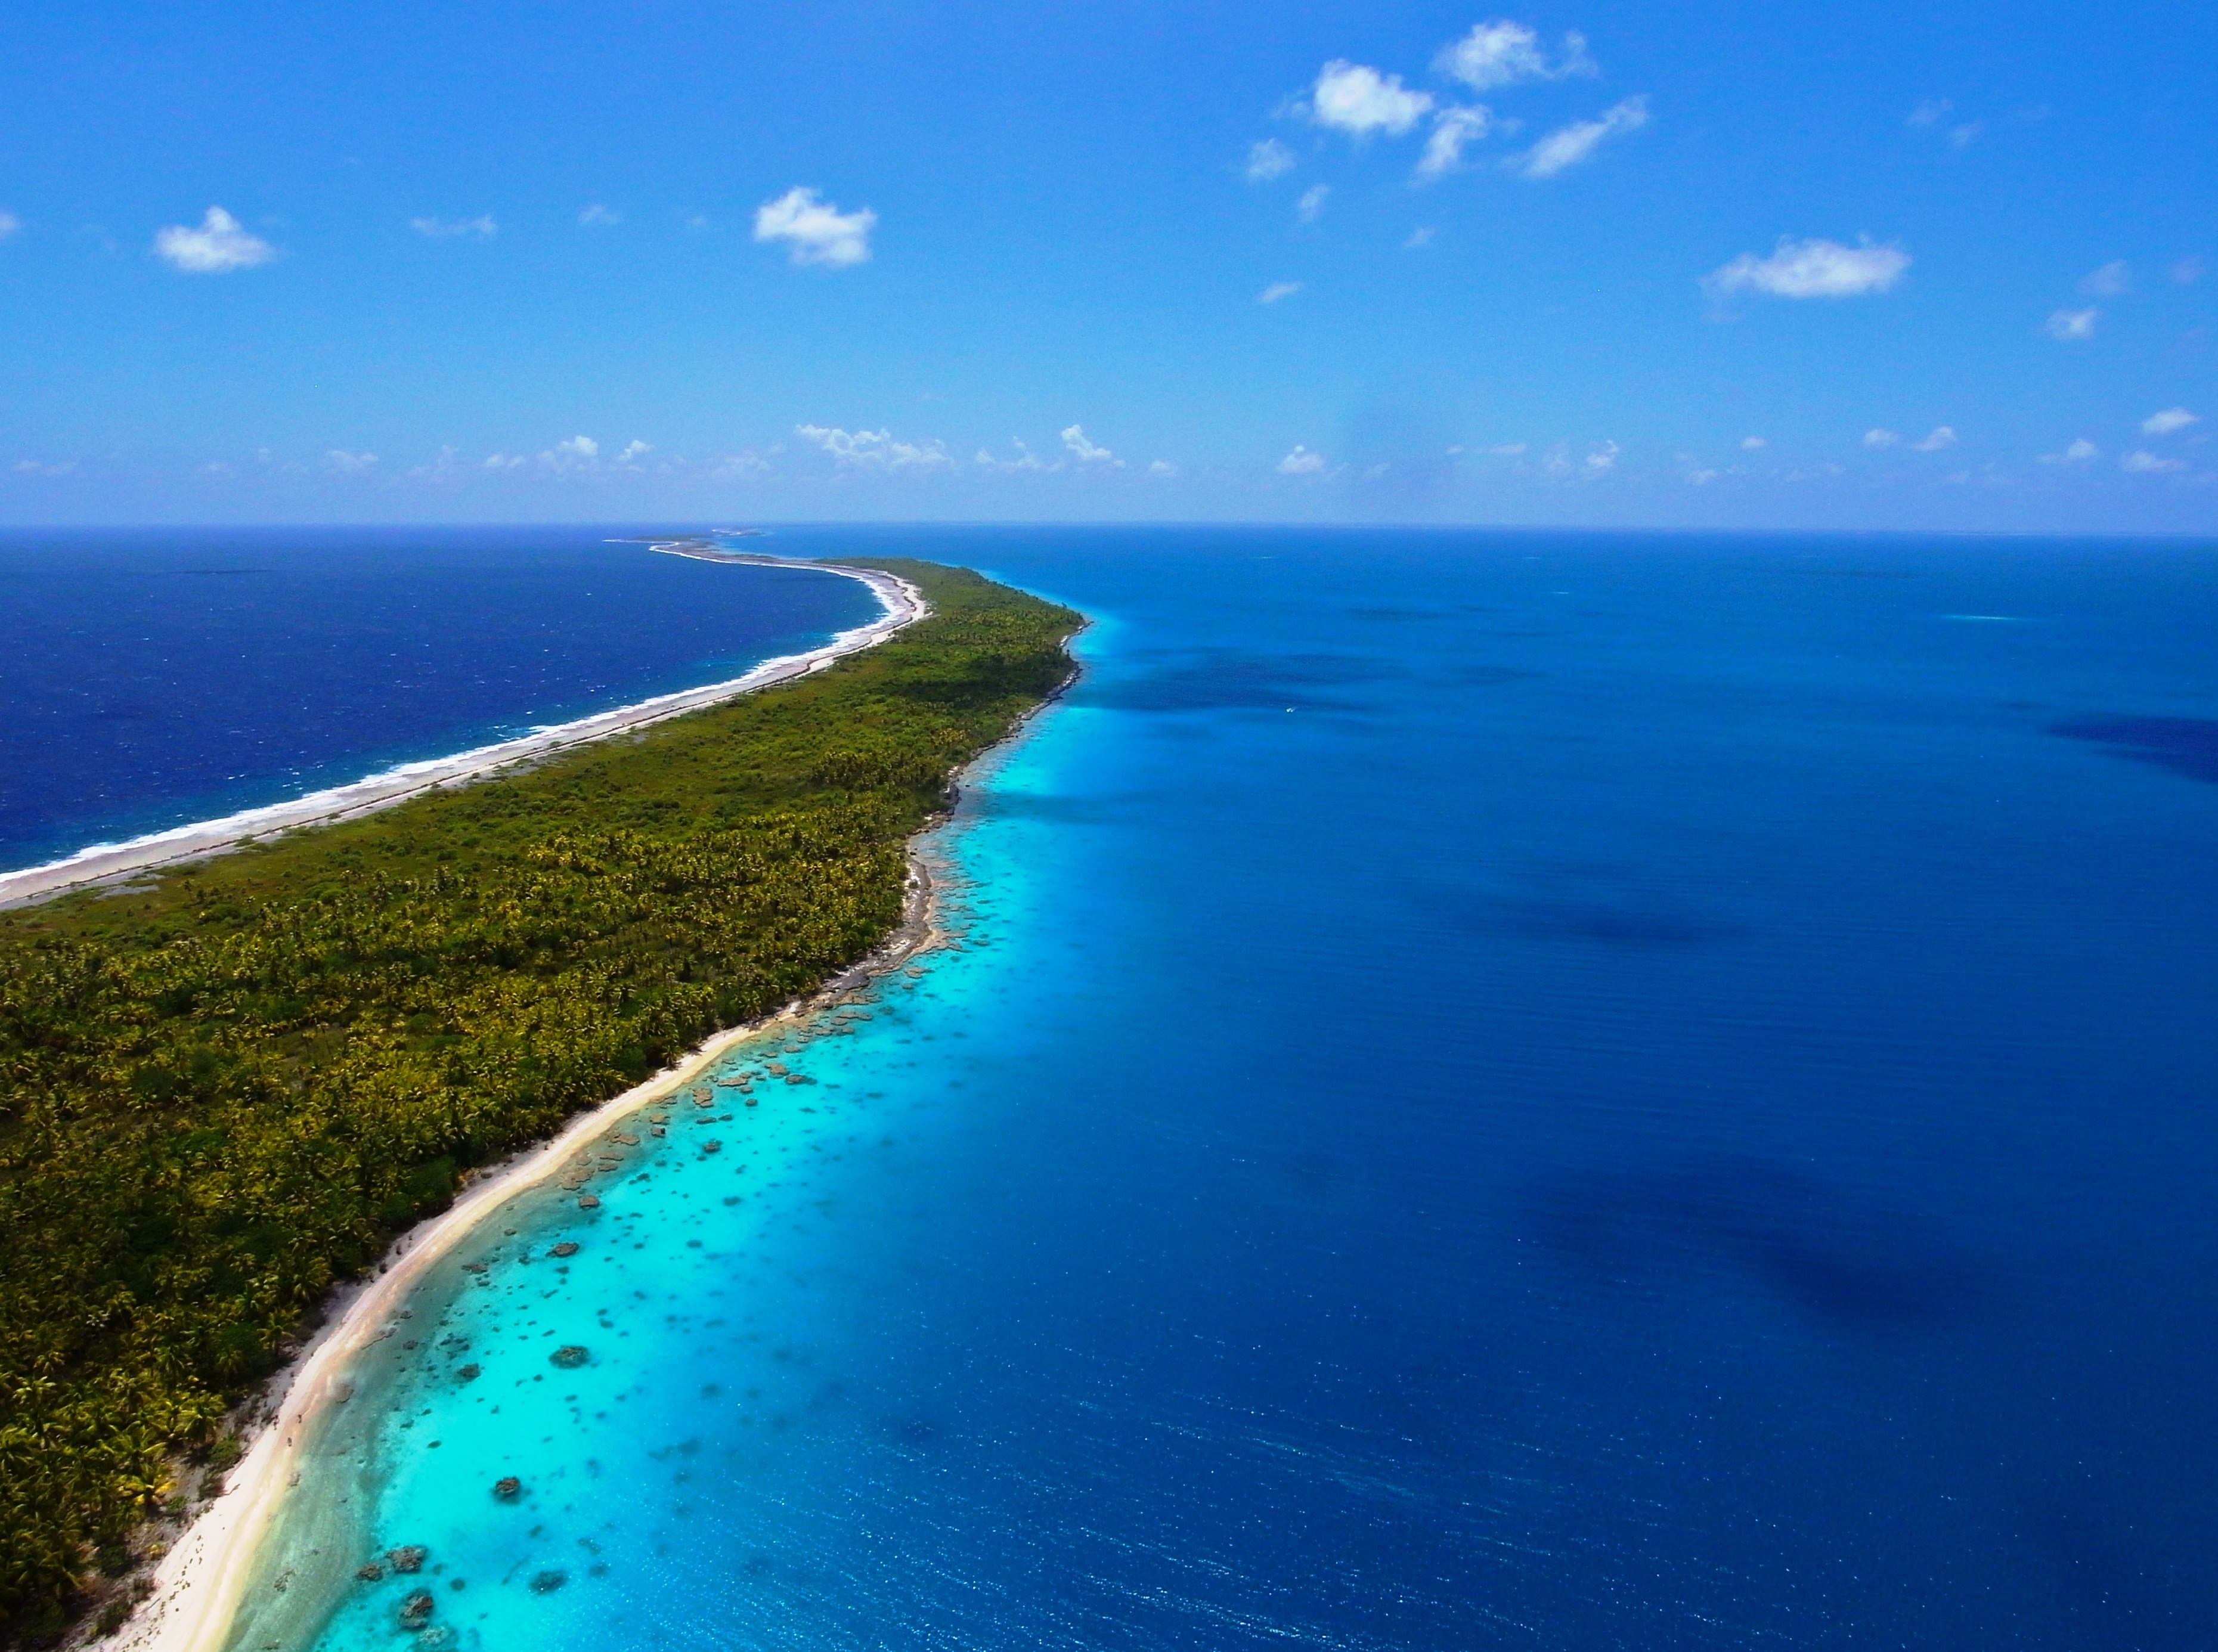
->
[[115, 851, 934, 1652]]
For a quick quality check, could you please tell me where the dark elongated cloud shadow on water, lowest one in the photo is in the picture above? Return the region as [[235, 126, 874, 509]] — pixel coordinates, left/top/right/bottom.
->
[[1526, 1155, 1994, 1328]]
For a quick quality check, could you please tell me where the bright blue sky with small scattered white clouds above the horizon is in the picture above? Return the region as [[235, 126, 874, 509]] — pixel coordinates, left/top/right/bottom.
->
[[0, 0, 2218, 532]]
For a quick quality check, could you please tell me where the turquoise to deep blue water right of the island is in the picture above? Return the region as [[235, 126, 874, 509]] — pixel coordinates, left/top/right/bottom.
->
[[21, 528, 2218, 1652]]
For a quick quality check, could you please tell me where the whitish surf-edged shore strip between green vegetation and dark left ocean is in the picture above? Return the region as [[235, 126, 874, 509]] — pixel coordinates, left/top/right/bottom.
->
[[0, 561, 931, 909]]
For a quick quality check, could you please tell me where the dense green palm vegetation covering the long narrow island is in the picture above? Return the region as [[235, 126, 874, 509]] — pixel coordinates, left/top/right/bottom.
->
[[0, 561, 1080, 1636]]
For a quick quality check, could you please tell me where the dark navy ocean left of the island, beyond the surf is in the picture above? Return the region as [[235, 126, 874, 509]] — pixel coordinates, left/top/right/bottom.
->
[[0, 528, 878, 872]]
